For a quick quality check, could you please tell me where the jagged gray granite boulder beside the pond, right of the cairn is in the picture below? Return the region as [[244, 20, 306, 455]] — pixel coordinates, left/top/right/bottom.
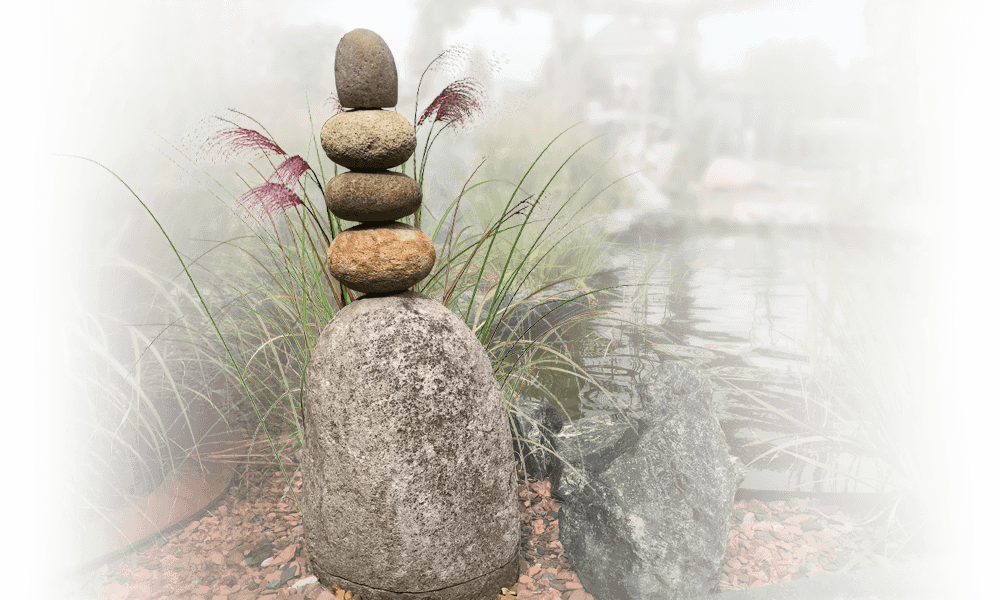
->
[[551, 361, 745, 600]]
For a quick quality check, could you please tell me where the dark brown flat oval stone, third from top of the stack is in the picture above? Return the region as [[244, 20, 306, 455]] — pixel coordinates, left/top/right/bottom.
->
[[325, 171, 424, 221]]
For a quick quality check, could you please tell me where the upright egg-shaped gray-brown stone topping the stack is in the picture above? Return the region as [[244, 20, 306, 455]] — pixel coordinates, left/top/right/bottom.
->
[[333, 28, 399, 108]]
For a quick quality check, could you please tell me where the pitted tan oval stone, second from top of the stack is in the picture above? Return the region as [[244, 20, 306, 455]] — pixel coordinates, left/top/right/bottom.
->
[[320, 109, 417, 171]]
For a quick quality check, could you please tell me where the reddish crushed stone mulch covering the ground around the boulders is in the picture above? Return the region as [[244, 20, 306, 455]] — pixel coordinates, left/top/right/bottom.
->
[[64, 452, 900, 600]]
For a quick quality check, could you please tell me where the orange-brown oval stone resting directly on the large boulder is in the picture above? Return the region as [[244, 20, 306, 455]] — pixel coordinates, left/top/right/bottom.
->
[[326, 221, 437, 294]]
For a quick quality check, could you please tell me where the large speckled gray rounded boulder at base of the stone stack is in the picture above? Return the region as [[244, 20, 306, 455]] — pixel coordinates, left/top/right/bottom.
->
[[302, 292, 520, 600]]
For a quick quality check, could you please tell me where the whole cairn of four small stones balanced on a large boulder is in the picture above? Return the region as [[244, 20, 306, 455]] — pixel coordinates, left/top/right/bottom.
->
[[302, 29, 520, 600]]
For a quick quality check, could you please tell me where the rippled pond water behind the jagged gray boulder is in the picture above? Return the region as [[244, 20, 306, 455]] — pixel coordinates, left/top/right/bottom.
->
[[527, 229, 916, 491]]
